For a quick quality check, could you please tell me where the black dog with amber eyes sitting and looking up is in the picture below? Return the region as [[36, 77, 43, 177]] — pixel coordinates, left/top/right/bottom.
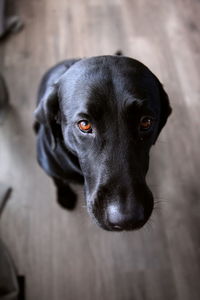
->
[[35, 56, 171, 231]]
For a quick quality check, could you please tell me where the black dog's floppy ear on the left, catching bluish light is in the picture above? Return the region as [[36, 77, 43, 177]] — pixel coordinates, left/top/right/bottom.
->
[[34, 84, 60, 150]]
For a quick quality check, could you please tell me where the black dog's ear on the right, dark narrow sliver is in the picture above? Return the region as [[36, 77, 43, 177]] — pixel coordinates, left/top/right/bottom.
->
[[154, 80, 172, 144]]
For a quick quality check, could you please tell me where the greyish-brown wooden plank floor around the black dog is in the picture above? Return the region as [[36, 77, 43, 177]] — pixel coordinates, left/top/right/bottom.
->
[[0, 0, 200, 300]]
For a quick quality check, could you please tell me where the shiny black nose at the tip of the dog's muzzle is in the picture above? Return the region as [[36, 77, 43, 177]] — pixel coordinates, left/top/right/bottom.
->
[[106, 204, 148, 231]]
